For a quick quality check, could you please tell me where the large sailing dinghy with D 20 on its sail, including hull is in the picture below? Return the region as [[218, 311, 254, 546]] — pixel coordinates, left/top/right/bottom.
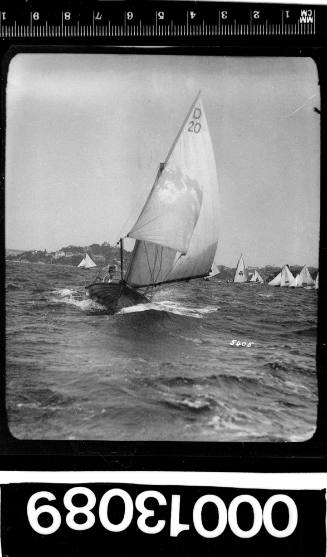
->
[[86, 93, 219, 313]]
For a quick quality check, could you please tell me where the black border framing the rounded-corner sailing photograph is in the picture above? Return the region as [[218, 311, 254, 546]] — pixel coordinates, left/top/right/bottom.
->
[[0, 2, 327, 472]]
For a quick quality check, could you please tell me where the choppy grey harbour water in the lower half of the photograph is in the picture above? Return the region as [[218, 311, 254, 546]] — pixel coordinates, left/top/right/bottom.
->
[[6, 262, 317, 441]]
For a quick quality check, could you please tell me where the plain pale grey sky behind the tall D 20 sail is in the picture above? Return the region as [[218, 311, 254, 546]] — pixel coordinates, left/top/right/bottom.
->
[[6, 53, 320, 266]]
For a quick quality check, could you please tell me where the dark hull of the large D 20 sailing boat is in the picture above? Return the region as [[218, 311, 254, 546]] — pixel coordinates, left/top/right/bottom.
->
[[85, 282, 149, 313]]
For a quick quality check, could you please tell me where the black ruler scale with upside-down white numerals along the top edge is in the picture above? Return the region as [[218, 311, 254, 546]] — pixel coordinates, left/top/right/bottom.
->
[[0, 0, 327, 42]]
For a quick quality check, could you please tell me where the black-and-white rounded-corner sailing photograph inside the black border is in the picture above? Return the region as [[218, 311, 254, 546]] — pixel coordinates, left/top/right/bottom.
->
[[5, 51, 320, 442]]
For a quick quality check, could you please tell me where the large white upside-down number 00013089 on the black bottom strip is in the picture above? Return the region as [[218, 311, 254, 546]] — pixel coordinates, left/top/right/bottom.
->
[[27, 486, 298, 538]]
